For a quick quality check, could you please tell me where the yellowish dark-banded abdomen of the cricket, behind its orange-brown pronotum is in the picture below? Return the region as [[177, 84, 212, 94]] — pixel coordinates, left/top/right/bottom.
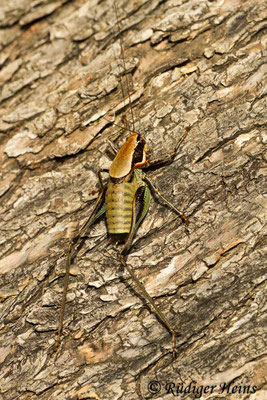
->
[[106, 181, 137, 235]]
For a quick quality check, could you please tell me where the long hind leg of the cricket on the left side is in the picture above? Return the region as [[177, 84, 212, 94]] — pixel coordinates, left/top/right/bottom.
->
[[53, 186, 106, 352]]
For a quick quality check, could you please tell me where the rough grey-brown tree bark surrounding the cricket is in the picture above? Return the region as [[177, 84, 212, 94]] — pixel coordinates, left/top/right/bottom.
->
[[0, 0, 267, 400]]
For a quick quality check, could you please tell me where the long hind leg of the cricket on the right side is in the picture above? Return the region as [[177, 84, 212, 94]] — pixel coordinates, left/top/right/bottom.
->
[[120, 185, 176, 359]]
